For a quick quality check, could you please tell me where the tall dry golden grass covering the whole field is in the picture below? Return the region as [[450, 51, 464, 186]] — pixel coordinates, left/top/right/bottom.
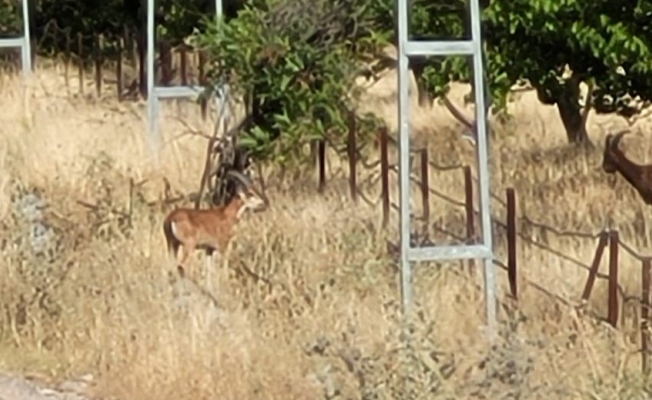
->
[[0, 60, 650, 400]]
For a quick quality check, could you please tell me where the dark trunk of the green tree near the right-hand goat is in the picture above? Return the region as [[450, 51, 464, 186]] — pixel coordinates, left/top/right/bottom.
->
[[556, 77, 592, 146]]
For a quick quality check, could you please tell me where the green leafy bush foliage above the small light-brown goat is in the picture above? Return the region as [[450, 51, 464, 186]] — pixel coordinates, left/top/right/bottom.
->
[[194, 0, 383, 164]]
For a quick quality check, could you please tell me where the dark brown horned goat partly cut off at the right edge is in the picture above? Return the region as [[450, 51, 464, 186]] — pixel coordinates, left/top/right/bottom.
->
[[602, 131, 652, 204]]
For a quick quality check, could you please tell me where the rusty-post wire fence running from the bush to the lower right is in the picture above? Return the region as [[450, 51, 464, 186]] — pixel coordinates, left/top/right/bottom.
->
[[310, 124, 652, 373]]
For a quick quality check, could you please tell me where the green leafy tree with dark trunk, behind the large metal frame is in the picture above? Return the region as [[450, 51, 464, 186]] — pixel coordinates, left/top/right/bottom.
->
[[380, 0, 652, 144]]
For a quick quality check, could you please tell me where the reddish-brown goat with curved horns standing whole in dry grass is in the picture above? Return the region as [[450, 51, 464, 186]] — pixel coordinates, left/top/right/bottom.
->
[[163, 171, 269, 282]]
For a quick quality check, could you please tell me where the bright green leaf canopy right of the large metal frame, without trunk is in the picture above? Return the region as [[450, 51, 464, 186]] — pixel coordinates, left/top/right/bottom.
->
[[484, 0, 652, 115]]
